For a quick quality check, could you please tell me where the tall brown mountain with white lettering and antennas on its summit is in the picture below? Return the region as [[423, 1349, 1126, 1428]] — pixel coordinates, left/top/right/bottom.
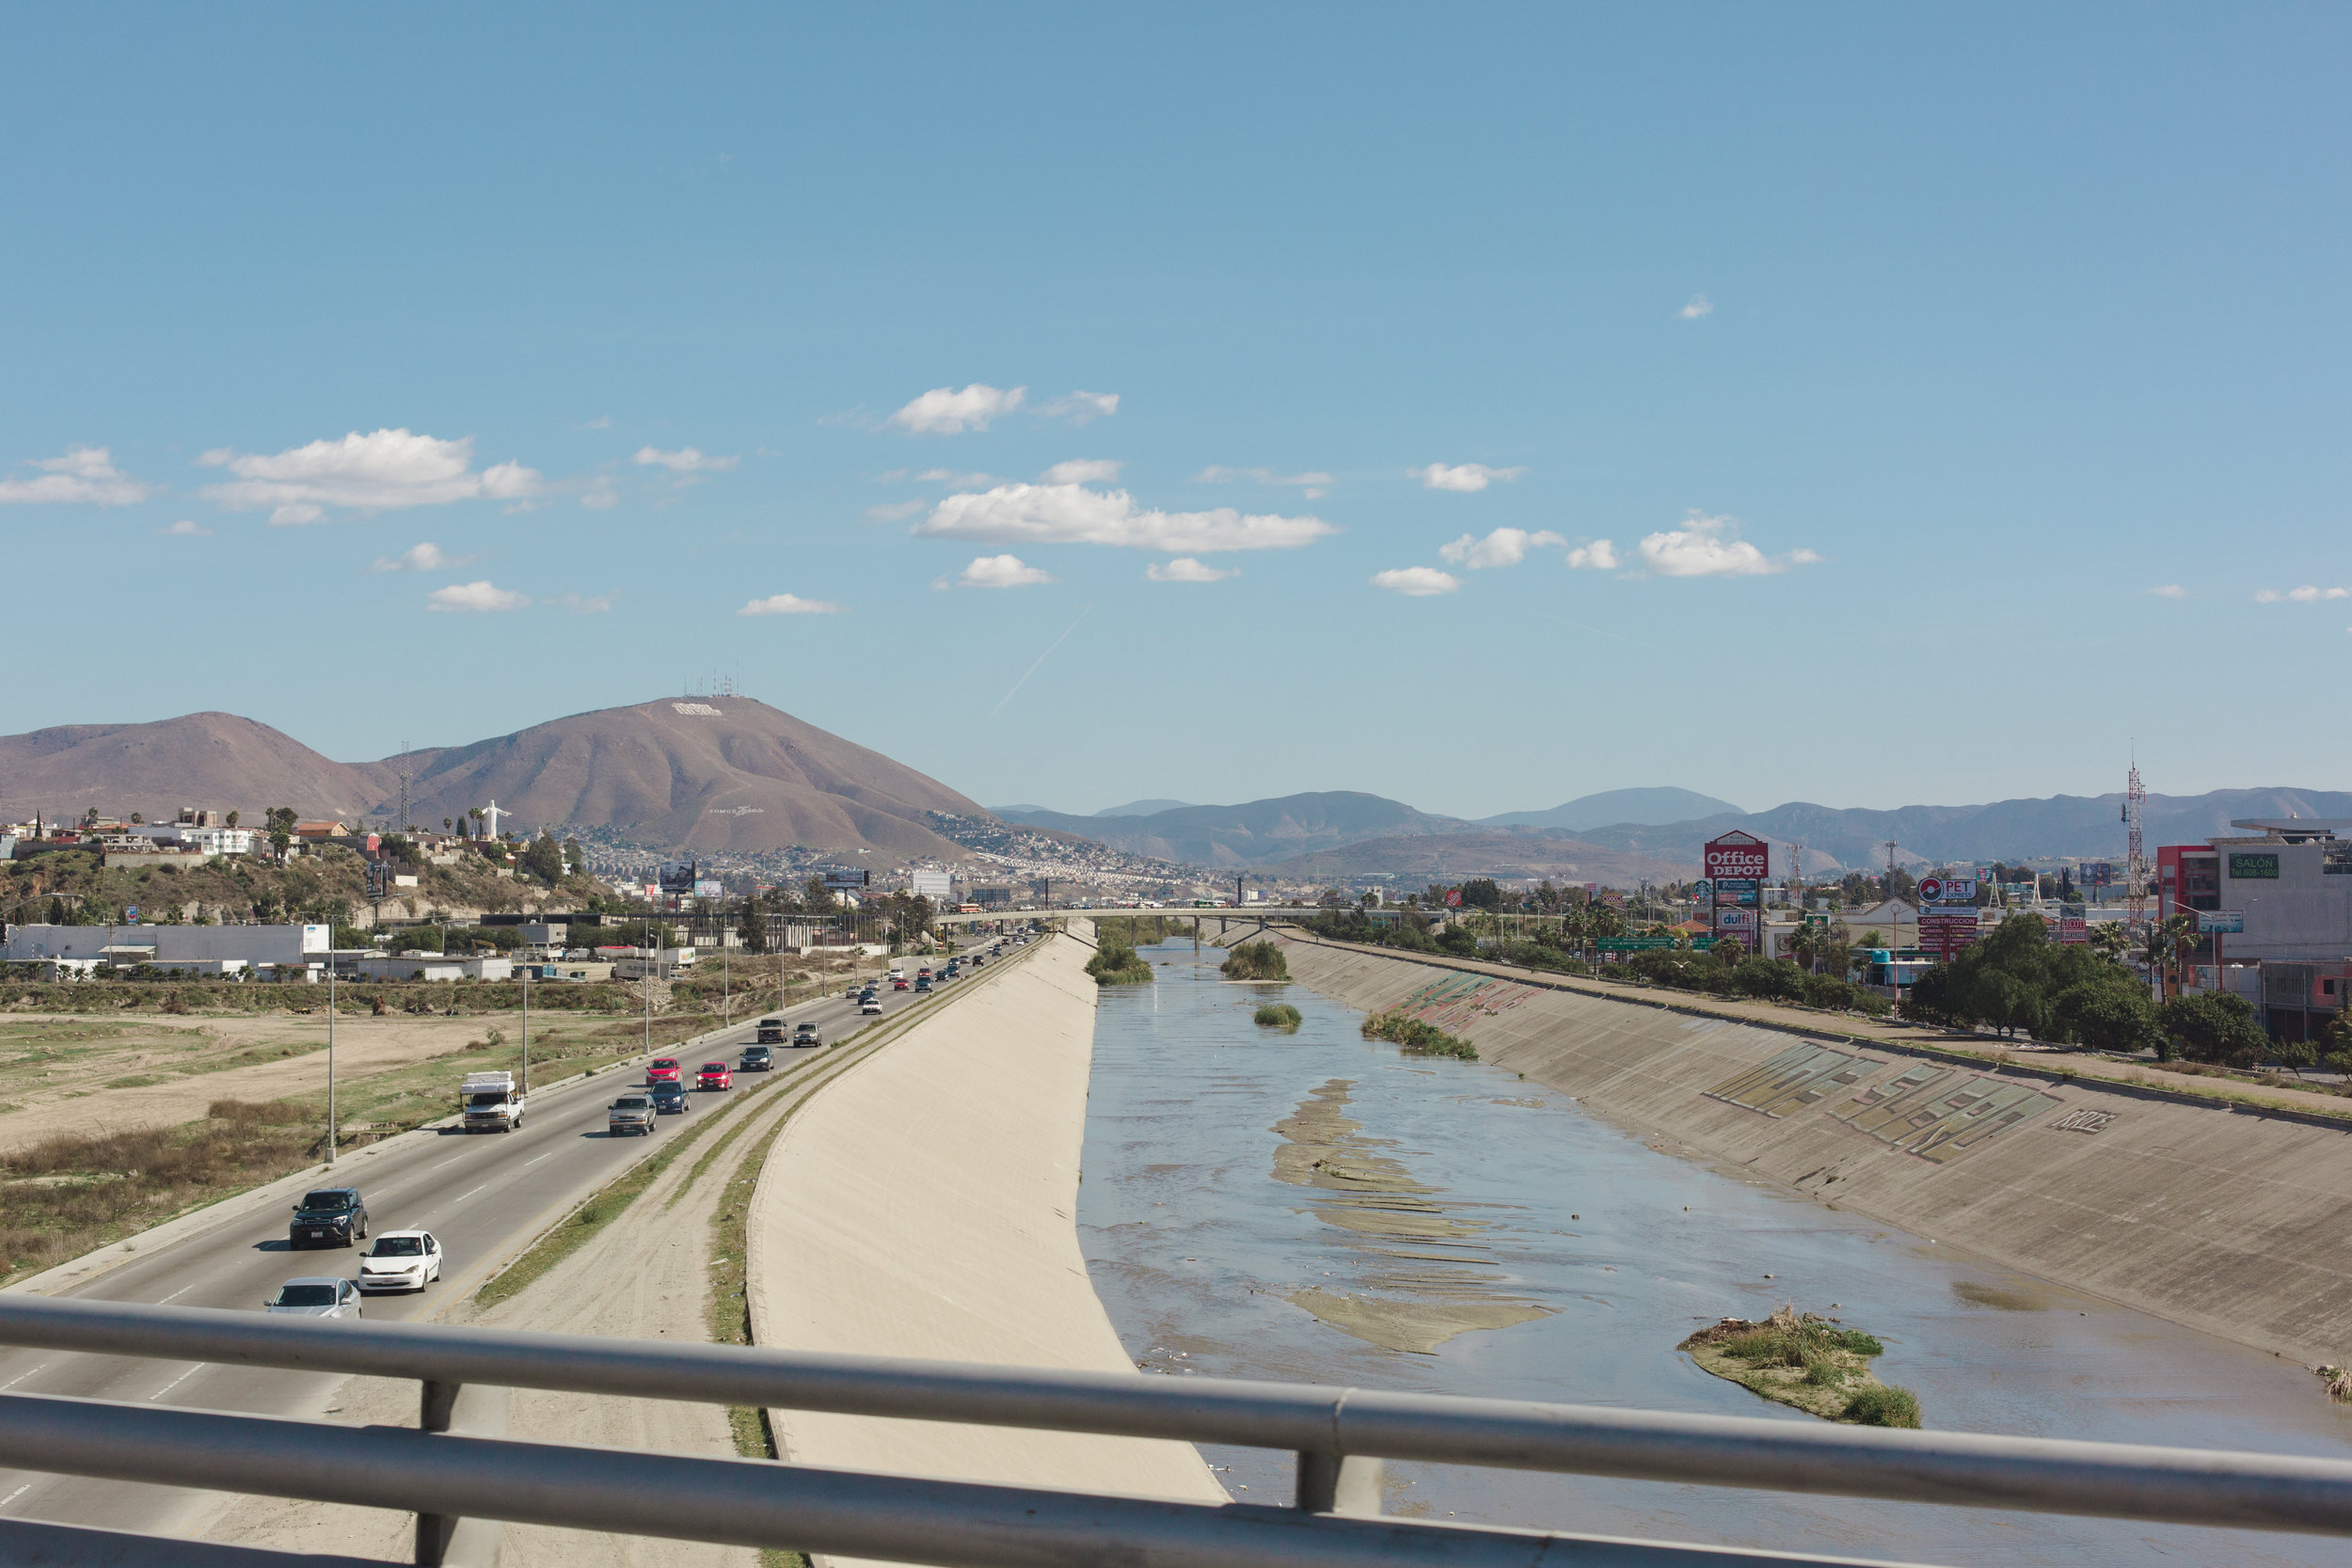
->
[[386, 696, 988, 861]]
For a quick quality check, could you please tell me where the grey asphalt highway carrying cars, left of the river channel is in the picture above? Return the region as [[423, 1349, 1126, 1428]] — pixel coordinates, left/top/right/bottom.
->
[[0, 940, 1011, 1533]]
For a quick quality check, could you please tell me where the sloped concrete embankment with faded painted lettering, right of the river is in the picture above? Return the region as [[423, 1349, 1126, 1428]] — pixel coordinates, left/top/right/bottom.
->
[[1284, 941, 2352, 1361]]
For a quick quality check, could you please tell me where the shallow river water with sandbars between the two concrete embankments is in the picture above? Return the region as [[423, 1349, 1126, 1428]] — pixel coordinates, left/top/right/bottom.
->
[[1077, 941, 2352, 1566]]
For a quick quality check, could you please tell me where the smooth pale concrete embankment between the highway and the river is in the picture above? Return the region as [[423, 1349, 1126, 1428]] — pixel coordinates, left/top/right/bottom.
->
[[748, 938, 1226, 1561]]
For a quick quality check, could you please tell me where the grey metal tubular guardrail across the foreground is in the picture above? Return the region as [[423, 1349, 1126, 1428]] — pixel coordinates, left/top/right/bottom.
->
[[0, 1298, 2352, 1568]]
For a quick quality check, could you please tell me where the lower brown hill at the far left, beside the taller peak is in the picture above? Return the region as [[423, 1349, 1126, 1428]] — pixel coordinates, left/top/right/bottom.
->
[[0, 712, 390, 823]]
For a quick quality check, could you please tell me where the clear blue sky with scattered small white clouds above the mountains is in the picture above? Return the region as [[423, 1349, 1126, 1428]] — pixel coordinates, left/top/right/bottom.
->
[[0, 5, 2352, 816]]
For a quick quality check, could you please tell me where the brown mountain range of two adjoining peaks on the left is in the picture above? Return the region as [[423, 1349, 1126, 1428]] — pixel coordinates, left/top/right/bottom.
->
[[0, 698, 988, 858]]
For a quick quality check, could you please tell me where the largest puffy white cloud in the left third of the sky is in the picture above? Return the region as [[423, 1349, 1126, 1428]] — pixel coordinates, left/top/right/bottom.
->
[[198, 430, 544, 527]]
